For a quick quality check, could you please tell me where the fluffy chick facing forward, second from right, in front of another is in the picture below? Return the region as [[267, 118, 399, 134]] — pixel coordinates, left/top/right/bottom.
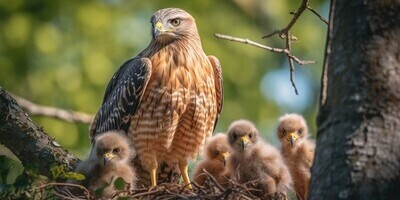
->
[[228, 120, 291, 199]]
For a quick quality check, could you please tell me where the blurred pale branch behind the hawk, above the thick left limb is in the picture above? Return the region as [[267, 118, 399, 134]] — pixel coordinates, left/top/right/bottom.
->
[[13, 95, 93, 124]]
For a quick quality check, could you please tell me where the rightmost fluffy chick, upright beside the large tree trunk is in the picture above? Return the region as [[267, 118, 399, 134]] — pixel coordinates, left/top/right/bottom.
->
[[277, 114, 315, 200]]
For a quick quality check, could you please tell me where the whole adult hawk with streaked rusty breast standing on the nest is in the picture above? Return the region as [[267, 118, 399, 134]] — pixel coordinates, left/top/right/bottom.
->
[[90, 8, 223, 186]]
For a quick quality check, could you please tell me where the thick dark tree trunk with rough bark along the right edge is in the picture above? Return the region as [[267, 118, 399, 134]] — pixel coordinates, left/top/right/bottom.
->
[[310, 0, 400, 200]]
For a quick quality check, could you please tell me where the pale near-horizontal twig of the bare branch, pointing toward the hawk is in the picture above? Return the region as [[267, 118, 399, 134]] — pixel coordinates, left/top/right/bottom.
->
[[214, 33, 316, 65]]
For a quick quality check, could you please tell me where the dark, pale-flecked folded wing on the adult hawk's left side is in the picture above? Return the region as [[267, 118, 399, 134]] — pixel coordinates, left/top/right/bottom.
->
[[89, 57, 151, 142]]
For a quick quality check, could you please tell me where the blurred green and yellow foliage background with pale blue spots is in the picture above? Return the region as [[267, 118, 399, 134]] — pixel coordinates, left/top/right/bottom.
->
[[0, 0, 329, 184]]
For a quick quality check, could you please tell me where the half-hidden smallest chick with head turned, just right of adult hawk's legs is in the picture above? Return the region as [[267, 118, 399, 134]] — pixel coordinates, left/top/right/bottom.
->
[[194, 133, 230, 185]]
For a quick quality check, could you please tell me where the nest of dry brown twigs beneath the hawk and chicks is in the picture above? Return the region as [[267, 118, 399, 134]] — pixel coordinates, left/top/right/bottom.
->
[[18, 171, 287, 200]]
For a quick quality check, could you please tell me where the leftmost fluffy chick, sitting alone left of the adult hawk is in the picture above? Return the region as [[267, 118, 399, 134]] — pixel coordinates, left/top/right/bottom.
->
[[71, 131, 136, 198]]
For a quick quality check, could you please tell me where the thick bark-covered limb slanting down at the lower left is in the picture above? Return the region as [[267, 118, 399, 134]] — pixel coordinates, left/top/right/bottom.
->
[[0, 87, 78, 177]]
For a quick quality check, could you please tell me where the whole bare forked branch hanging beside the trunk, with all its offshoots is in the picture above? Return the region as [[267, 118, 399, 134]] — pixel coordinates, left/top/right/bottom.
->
[[215, 0, 328, 95]]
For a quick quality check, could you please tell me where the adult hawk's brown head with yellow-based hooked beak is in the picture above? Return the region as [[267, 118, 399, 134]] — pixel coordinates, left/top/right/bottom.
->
[[151, 8, 199, 43]]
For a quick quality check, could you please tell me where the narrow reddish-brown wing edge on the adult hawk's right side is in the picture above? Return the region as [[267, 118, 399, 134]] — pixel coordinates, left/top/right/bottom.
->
[[208, 56, 224, 130]]
